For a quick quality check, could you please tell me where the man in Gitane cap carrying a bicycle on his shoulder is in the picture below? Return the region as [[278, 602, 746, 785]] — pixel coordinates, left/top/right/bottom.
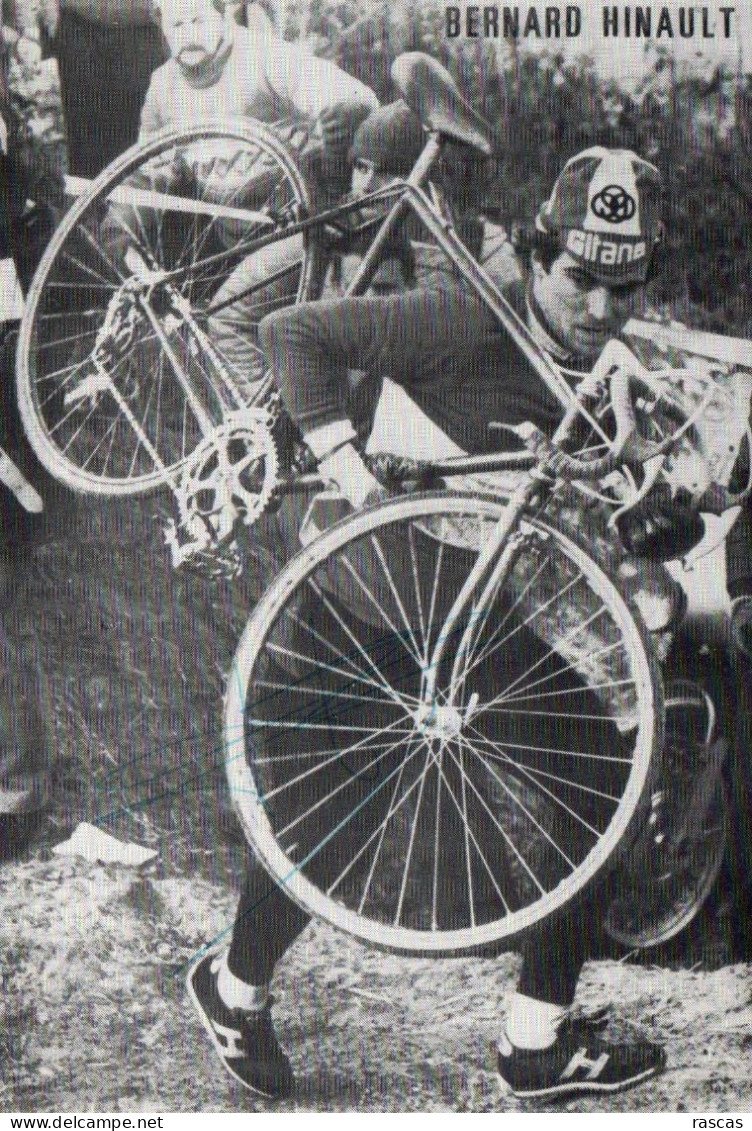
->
[[188, 148, 673, 1097]]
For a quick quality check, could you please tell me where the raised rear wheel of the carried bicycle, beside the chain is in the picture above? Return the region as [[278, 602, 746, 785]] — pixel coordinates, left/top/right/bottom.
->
[[18, 124, 310, 494]]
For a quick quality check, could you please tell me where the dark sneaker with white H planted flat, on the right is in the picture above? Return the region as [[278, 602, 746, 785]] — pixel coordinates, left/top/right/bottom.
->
[[499, 1019, 666, 1097]]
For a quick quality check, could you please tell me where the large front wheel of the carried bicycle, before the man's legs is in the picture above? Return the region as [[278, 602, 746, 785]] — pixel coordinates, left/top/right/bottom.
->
[[226, 498, 656, 953]]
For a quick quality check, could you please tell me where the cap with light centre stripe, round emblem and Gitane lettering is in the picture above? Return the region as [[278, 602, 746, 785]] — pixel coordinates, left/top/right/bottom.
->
[[536, 146, 663, 284]]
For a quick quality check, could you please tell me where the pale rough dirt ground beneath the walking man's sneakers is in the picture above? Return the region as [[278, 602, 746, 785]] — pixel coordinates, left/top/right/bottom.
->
[[0, 858, 752, 1112]]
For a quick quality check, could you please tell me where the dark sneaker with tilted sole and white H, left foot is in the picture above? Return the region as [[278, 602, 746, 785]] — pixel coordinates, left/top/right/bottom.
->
[[185, 953, 294, 1099]]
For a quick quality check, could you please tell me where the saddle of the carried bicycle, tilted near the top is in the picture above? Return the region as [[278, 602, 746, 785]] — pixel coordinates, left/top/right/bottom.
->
[[391, 51, 492, 157]]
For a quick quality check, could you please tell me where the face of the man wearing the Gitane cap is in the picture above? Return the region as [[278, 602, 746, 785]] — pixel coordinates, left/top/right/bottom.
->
[[533, 251, 645, 360]]
